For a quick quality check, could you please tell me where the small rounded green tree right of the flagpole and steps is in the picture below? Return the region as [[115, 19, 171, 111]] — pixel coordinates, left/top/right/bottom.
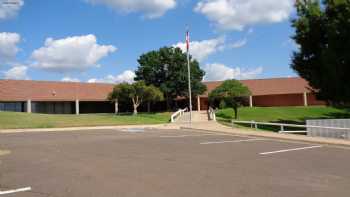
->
[[209, 79, 251, 119]]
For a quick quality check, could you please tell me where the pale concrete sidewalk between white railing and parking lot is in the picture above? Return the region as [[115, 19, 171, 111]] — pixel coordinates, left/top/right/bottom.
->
[[180, 121, 350, 147]]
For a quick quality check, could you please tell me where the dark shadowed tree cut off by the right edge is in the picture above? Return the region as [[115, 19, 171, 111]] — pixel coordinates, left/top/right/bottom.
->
[[291, 0, 350, 104]]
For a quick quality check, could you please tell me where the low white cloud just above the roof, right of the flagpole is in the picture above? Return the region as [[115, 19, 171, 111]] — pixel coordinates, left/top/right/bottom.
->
[[204, 63, 263, 81]]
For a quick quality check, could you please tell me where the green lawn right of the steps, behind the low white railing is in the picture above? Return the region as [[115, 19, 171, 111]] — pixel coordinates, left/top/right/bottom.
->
[[216, 106, 350, 130]]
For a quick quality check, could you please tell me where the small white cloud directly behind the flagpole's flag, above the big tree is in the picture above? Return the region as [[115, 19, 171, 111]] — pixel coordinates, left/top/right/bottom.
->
[[173, 37, 225, 62]]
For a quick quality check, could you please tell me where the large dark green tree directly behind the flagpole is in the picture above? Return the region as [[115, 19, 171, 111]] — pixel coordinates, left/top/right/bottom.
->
[[135, 47, 206, 110]]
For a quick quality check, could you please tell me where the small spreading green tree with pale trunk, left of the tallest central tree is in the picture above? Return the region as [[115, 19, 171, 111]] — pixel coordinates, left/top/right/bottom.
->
[[108, 81, 162, 115]]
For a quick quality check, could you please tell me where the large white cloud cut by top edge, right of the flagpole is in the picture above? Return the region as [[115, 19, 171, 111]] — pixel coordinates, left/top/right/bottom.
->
[[194, 0, 294, 31]]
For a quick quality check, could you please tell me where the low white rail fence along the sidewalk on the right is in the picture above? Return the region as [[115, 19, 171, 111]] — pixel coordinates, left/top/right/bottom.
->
[[232, 120, 350, 139]]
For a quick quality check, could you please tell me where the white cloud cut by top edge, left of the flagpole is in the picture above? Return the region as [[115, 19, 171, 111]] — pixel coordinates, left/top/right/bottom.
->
[[85, 0, 176, 18]]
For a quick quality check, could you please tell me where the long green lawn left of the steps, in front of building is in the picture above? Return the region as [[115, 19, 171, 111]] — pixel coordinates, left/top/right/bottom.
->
[[0, 112, 171, 129]]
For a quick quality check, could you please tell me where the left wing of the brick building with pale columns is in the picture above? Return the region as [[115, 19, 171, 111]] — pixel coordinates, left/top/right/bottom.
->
[[0, 80, 114, 114]]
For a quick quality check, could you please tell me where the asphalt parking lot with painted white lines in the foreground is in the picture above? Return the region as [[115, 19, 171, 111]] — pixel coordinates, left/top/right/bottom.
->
[[0, 129, 350, 197]]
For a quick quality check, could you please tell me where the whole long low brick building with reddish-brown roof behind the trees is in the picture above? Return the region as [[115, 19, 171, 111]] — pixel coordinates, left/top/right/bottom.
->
[[0, 78, 325, 114]]
